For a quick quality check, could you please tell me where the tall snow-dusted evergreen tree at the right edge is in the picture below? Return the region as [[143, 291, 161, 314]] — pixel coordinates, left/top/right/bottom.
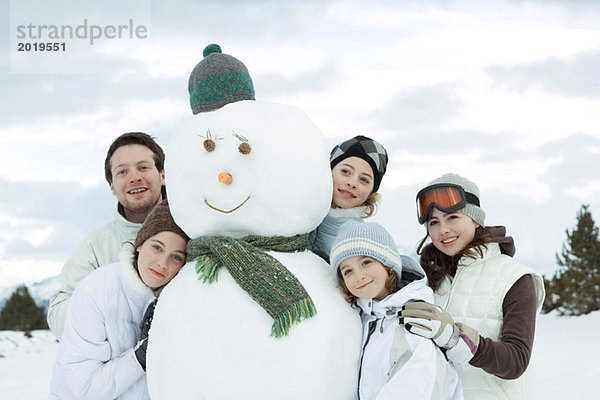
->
[[543, 205, 600, 315]]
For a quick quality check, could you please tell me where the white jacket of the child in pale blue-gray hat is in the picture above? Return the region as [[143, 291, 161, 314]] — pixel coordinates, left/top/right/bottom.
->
[[358, 263, 463, 400]]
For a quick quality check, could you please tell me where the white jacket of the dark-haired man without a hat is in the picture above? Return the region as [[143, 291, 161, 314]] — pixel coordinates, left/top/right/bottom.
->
[[48, 210, 142, 339]]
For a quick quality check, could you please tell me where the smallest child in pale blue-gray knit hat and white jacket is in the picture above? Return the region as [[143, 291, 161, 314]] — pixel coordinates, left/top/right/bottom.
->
[[331, 220, 463, 400]]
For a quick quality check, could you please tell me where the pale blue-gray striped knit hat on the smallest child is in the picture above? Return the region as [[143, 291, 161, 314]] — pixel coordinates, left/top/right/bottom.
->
[[329, 220, 402, 276]]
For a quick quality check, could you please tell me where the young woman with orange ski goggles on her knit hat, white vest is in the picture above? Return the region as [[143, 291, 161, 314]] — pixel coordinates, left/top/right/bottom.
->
[[401, 174, 544, 400]]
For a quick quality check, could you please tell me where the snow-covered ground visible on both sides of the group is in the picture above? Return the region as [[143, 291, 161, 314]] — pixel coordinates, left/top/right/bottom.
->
[[0, 311, 600, 400]]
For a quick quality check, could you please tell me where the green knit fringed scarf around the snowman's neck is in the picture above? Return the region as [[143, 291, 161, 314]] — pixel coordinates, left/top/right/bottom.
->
[[187, 234, 317, 338]]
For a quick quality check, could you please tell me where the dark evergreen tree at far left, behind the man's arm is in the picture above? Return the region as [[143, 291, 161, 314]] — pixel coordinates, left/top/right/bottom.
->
[[0, 285, 48, 332]]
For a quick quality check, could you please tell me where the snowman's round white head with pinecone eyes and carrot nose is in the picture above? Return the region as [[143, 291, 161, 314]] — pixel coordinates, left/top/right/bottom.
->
[[165, 101, 332, 238]]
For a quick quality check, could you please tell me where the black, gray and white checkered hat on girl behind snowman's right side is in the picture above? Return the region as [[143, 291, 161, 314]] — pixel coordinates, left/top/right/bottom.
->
[[329, 135, 388, 192]]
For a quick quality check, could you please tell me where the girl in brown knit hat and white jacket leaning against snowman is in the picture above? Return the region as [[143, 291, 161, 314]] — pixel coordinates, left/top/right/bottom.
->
[[49, 200, 189, 399]]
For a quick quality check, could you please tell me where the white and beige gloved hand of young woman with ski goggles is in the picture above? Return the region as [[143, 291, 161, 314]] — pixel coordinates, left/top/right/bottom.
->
[[399, 301, 479, 364]]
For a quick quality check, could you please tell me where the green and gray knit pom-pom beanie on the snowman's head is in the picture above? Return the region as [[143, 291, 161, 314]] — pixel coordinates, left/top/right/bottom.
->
[[188, 44, 255, 114]]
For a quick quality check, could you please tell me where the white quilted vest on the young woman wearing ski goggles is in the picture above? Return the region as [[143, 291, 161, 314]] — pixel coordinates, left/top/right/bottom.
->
[[435, 243, 544, 400]]
